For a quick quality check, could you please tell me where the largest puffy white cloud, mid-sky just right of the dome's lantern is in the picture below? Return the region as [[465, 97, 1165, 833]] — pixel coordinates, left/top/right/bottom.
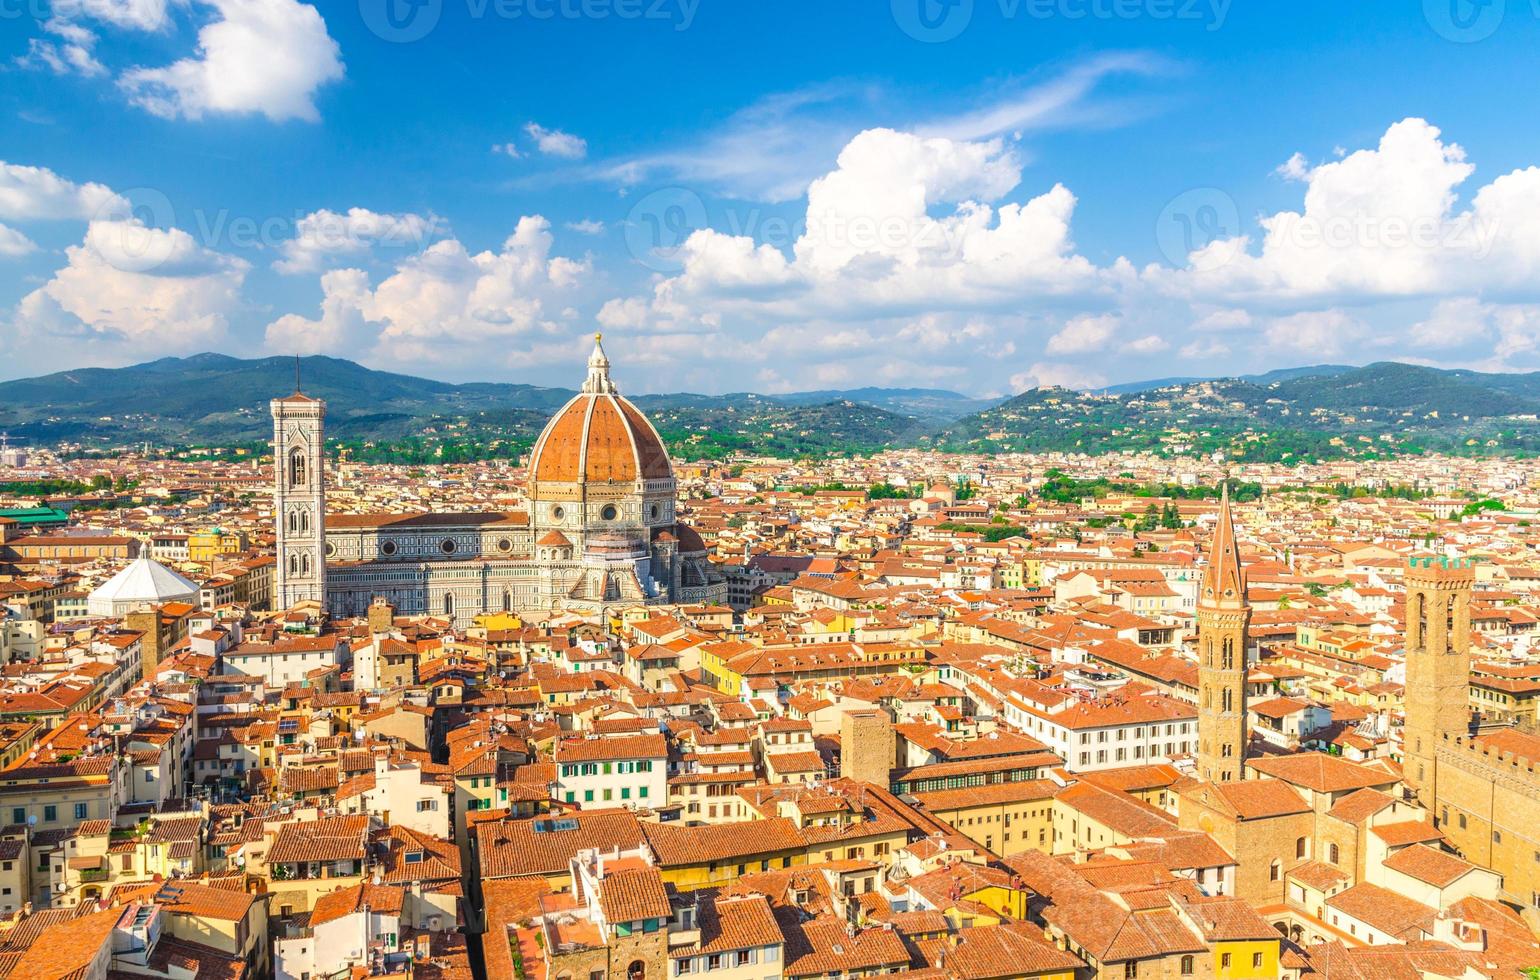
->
[[625, 129, 1132, 332]]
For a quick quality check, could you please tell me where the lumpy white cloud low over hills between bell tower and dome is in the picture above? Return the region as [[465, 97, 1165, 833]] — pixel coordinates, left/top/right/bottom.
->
[[266, 217, 590, 364]]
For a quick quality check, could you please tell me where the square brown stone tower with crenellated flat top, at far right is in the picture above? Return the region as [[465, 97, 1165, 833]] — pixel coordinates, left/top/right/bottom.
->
[[1401, 558, 1475, 811]]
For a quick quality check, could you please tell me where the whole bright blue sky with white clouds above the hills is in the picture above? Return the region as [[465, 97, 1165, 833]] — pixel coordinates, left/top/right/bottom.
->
[[0, 0, 1540, 394]]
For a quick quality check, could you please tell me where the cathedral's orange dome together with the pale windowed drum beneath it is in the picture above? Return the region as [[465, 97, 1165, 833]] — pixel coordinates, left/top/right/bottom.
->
[[528, 337, 676, 561]]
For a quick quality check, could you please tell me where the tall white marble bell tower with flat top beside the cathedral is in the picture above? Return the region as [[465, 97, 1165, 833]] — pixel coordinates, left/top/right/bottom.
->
[[271, 385, 326, 609]]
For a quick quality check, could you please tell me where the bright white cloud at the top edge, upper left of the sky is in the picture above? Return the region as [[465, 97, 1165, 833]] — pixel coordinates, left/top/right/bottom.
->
[[119, 0, 343, 122]]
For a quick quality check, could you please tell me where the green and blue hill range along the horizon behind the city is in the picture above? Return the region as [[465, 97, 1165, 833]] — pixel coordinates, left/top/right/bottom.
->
[[9, 354, 1540, 459]]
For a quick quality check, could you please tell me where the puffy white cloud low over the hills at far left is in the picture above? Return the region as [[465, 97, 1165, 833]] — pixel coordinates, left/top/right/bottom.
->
[[14, 220, 248, 354]]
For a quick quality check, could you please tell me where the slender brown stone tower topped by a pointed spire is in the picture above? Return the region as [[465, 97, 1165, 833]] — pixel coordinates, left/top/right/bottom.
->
[[1198, 484, 1250, 783]]
